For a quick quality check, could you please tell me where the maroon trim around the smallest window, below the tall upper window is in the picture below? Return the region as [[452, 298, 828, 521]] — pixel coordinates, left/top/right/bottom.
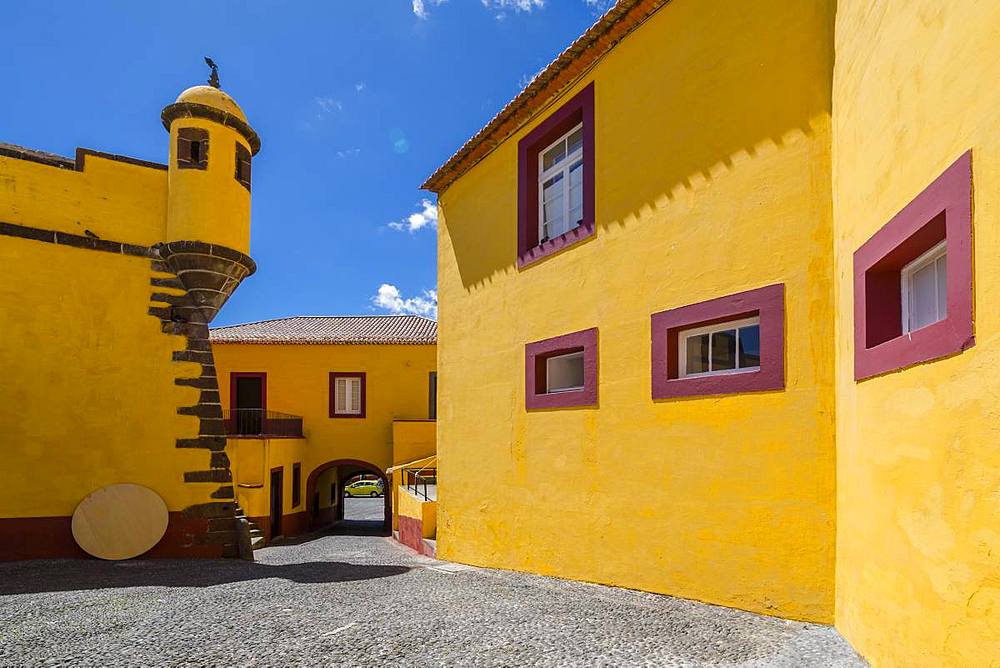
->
[[524, 327, 598, 411]]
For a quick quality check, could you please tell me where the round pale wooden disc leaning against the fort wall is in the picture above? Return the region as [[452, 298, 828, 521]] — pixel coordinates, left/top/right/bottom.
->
[[73, 483, 168, 560]]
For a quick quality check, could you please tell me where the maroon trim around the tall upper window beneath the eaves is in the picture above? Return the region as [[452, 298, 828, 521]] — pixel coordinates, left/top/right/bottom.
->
[[517, 83, 594, 269]]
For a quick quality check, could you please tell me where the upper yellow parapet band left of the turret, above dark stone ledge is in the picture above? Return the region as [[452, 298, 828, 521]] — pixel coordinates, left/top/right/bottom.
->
[[0, 153, 167, 246]]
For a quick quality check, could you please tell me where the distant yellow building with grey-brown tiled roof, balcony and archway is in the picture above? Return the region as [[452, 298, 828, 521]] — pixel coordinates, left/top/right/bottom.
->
[[211, 315, 437, 543]]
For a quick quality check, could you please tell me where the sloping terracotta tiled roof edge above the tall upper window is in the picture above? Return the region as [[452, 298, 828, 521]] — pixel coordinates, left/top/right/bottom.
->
[[421, 0, 669, 193]]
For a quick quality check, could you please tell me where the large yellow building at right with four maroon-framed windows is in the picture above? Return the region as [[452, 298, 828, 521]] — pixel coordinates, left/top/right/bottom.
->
[[424, 0, 1000, 666]]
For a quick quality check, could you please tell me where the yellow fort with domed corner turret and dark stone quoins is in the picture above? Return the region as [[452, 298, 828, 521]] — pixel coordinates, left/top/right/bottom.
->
[[0, 77, 260, 559]]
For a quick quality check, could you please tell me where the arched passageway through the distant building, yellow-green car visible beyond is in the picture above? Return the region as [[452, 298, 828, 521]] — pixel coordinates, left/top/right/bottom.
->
[[306, 459, 392, 533]]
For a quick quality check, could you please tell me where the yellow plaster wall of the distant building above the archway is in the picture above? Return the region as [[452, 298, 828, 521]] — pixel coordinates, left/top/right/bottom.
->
[[213, 343, 436, 517]]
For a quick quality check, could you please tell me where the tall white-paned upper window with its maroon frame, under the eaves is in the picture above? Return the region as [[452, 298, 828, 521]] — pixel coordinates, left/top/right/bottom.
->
[[517, 84, 594, 267]]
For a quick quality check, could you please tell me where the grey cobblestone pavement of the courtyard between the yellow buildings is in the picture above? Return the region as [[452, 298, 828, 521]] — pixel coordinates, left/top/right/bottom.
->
[[0, 523, 864, 668]]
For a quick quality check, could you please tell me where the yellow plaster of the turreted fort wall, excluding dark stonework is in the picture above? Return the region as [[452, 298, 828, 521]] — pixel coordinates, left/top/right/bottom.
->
[[0, 87, 258, 552]]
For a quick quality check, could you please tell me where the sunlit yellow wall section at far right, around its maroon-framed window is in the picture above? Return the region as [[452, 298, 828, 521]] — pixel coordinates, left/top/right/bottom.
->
[[833, 0, 1000, 667]]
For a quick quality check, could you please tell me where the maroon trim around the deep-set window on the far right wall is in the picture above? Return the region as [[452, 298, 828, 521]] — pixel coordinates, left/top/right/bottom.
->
[[854, 151, 976, 381]]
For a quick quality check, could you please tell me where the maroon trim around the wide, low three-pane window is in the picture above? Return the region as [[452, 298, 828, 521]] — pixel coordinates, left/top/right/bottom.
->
[[650, 283, 785, 399]]
